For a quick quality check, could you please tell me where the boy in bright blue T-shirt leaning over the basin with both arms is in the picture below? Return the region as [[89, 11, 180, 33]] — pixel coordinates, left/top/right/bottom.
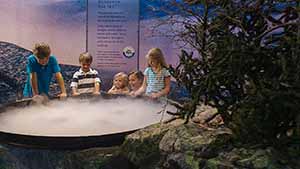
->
[[23, 43, 67, 98]]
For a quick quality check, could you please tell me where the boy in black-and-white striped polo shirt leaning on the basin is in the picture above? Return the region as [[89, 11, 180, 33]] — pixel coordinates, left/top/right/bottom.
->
[[71, 52, 101, 96]]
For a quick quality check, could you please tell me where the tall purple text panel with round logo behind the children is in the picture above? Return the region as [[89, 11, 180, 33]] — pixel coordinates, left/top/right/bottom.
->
[[87, 0, 139, 72]]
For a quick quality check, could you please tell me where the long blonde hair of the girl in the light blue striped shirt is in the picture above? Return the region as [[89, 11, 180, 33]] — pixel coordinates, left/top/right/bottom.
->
[[146, 48, 168, 70]]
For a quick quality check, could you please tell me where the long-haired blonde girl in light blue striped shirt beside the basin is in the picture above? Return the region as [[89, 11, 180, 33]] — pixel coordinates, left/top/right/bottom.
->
[[132, 48, 171, 99]]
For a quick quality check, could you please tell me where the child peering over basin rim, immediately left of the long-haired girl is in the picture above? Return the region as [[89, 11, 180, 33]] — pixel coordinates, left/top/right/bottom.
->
[[128, 71, 144, 95]]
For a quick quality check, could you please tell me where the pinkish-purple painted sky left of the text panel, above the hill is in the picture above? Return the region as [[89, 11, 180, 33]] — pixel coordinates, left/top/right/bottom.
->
[[0, 0, 86, 64]]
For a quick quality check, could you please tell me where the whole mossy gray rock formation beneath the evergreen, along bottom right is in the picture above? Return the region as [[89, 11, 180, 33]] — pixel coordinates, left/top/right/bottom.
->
[[121, 119, 300, 169]]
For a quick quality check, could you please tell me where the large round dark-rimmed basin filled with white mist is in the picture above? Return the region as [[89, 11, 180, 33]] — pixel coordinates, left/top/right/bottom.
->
[[0, 96, 174, 150]]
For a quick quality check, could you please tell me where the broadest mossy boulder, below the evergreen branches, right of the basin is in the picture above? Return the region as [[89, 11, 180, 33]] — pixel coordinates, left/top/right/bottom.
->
[[159, 123, 232, 158]]
